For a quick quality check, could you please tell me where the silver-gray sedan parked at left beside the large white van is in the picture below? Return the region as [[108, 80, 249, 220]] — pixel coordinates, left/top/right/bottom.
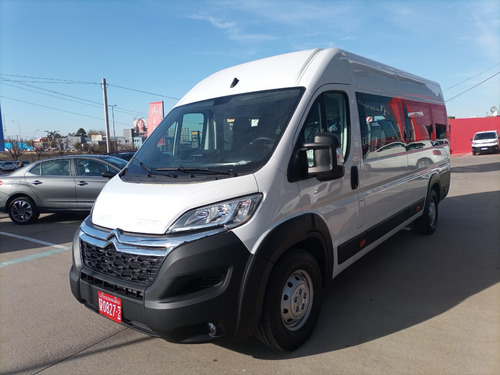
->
[[0, 155, 127, 224]]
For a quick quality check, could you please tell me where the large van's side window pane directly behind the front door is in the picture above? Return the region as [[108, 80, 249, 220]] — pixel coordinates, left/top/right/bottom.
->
[[356, 93, 409, 159]]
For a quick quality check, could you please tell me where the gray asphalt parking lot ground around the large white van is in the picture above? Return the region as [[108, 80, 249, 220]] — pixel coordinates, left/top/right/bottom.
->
[[0, 155, 500, 375]]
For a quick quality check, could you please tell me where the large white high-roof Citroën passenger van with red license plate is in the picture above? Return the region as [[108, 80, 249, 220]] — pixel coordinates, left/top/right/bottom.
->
[[70, 48, 450, 350]]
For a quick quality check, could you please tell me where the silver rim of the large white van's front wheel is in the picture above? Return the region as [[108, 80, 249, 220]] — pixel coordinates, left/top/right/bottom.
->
[[281, 270, 314, 331]]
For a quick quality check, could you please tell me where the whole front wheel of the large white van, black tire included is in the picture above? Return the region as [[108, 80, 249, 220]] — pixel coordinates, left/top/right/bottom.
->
[[255, 249, 322, 351]]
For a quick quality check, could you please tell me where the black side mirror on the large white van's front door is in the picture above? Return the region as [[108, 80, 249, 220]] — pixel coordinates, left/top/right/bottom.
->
[[304, 133, 345, 181]]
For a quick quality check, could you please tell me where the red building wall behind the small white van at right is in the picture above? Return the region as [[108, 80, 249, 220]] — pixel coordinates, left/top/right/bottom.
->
[[448, 116, 500, 154]]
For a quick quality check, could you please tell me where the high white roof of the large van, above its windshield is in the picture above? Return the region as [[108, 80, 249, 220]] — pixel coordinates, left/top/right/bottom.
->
[[176, 48, 443, 106]]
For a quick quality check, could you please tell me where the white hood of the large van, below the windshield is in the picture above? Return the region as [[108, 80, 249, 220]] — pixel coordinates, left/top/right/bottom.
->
[[92, 174, 258, 234]]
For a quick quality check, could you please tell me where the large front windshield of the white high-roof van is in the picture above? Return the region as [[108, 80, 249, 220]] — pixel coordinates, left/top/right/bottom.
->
[[127, 88, 304, 182]]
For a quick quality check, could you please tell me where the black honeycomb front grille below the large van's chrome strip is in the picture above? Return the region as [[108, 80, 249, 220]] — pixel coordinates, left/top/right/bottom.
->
[[80, 241, 165, 285]]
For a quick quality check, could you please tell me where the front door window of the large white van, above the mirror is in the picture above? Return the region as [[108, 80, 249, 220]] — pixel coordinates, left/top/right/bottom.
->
[[302, 91, 350, 158]]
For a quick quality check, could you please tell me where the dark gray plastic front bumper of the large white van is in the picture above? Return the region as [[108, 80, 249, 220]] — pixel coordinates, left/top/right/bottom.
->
[[70, 219, 270, 343]]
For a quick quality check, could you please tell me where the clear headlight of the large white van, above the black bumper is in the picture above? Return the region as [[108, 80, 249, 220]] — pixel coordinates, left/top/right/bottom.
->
[[167, 194, 262, 233]]
